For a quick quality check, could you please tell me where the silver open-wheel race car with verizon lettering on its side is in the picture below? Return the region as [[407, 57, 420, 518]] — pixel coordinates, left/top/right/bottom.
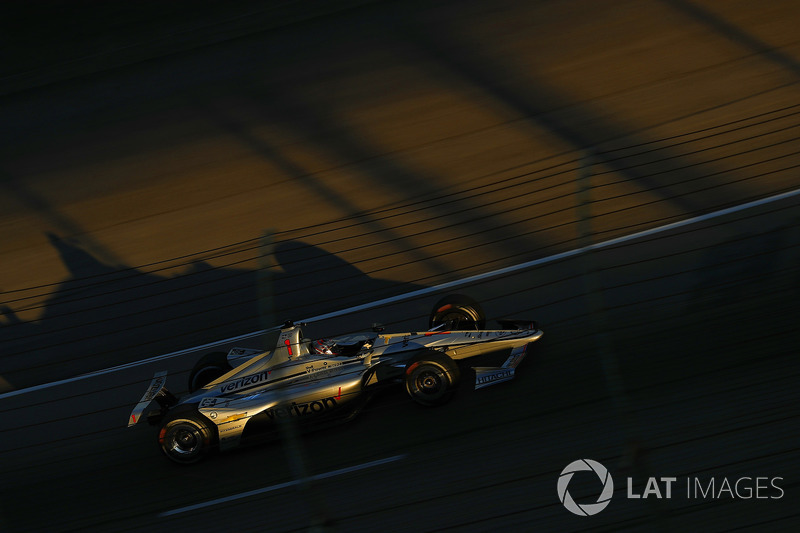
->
[[128, 295, 543, 464]]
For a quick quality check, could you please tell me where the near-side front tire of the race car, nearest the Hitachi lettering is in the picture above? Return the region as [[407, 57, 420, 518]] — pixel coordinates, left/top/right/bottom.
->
[[403, 351, 461, 407]]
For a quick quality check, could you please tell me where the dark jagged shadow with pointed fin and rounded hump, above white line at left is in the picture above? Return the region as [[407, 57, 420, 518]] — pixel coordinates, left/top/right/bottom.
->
[[0, 234, 422, 388]]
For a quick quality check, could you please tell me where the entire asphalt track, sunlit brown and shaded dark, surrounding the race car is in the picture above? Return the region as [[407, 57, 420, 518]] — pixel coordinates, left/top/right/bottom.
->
[[0, 2, 800, 531]]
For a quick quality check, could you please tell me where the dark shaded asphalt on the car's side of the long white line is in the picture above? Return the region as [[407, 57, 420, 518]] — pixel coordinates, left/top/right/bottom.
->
[[2, 192, 800, 531]]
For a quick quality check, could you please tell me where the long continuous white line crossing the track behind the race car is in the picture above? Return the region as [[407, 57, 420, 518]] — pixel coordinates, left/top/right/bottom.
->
[[0, 185, 800, 400]]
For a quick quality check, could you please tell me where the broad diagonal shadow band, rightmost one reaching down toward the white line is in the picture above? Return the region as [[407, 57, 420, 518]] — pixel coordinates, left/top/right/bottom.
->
[[406, 15, 761, 227]]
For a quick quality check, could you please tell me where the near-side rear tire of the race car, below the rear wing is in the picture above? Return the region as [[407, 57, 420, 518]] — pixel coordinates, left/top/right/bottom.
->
[[158, 409, 216, 465]]
